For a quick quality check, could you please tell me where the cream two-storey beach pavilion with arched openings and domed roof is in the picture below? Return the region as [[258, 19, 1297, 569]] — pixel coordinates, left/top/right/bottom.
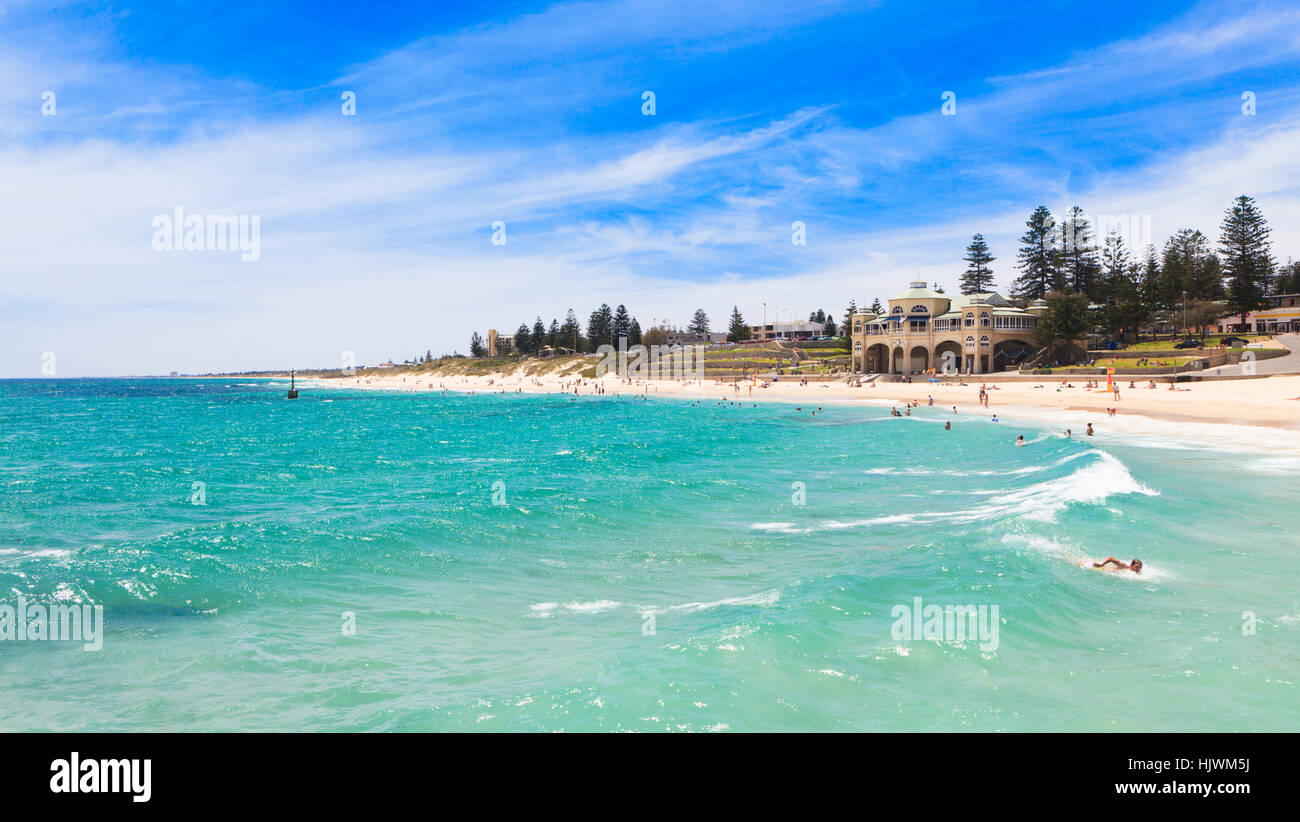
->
[[850, 282, 1048, 373]]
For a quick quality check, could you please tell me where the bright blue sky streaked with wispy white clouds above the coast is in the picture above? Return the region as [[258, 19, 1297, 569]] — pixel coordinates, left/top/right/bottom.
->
[[0, 0, 1300, 377]]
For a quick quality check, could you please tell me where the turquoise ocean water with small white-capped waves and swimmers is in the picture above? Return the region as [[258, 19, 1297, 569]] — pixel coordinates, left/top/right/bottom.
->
[[0, 380, 1300, 731]]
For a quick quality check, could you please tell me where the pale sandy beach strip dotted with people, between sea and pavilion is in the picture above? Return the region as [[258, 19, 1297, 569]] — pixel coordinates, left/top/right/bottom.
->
[[316, 373, 1300, 431]]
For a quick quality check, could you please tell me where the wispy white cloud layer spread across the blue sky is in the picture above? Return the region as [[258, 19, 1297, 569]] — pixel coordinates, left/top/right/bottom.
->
[[0, 4, 1300, 376]]
